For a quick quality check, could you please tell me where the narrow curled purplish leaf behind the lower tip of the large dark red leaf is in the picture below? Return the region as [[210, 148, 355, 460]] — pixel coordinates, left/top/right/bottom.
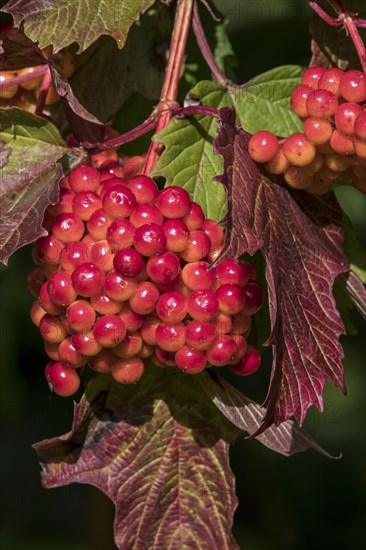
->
[[198, 372, 334, 458]]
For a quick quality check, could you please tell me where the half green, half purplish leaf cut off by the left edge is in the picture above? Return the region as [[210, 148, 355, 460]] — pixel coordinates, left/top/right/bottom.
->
[[0, 108, 79, 263]]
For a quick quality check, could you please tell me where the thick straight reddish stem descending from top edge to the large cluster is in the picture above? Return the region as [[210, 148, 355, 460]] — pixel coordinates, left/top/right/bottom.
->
[[144, 0, 193, 174]]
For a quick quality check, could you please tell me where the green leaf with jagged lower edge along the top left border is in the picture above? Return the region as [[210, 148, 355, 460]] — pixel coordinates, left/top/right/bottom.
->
[[4, 0, 155, 51]]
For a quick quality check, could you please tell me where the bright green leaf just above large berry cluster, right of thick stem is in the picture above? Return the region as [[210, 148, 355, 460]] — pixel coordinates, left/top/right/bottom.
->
[[152, 117, 226, 221]]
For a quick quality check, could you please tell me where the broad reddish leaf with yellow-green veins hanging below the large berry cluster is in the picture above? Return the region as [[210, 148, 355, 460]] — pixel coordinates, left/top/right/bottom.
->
[[34, 366, 240, 550]]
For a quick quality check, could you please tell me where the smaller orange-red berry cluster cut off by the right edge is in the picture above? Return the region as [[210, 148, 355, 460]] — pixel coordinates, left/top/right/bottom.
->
[[248, 67, 366, 195]]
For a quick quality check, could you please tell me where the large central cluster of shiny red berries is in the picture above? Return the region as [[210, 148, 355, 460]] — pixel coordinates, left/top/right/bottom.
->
[[28, 158, 263, 396]]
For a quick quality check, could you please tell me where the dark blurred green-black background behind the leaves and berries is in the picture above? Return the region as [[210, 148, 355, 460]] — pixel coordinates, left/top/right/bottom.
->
[[0, 0, 366, 550]]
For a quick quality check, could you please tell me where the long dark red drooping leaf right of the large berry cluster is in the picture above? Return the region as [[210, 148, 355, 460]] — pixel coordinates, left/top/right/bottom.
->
[[214, 109, 348, 430]]
